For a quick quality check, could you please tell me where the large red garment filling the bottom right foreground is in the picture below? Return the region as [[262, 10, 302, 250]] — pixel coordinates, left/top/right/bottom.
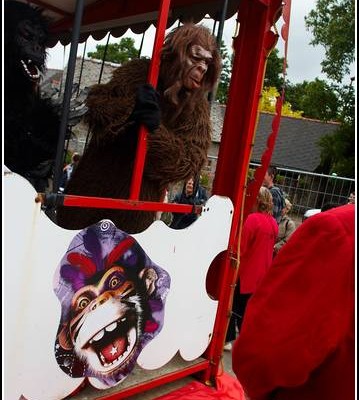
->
[[232, 205, 355, 400]]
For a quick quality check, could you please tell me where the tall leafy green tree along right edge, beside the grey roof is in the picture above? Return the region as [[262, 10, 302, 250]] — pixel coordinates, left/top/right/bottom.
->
[[305, 0, 355, 177]]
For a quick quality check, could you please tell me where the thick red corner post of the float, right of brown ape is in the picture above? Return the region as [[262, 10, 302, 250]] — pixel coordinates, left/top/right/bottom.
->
[[202, 0, 281, 381]]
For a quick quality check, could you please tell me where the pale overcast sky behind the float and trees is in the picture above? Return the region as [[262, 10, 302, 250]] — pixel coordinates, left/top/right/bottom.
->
[[47, 0, 354, 83]]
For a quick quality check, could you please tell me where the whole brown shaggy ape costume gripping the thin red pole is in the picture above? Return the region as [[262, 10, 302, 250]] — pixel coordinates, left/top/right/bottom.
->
[[57, 24, 220, 233]]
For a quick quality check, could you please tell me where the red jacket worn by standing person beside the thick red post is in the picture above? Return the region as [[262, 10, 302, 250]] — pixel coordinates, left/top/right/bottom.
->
[[239, 212, 278, 294]]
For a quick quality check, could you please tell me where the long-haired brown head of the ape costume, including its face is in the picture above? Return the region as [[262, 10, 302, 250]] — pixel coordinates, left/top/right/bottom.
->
[[160, 23, 221, 105]]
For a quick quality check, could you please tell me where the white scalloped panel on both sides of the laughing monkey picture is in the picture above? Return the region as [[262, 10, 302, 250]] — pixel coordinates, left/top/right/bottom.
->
[[3, 173, 232, 400]]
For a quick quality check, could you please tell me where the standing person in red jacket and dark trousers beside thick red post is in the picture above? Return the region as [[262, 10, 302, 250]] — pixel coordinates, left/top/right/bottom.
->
[[224, 186, 278, 350]]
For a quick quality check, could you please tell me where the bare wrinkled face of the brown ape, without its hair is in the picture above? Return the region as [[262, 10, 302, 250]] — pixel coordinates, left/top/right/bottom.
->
[[183, 45, 213, 90]]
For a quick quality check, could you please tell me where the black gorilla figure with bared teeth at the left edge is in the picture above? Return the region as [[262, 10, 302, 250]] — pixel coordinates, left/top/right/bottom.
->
[[4, 1, 60, 192]]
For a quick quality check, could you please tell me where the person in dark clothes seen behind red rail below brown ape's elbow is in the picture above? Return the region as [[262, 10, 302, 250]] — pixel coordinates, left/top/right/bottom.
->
[[169, 177, 208, 229]]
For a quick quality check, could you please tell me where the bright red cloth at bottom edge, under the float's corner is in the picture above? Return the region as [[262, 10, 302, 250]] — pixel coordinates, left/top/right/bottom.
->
[[156, 373, 245, 400]]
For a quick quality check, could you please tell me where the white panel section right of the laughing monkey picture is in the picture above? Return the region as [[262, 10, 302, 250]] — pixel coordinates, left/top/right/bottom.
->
[[134, 196, 232, 369]]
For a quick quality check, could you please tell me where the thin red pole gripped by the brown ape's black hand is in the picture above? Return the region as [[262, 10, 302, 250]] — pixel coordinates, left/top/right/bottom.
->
[[129, 0, 171, 200]]
